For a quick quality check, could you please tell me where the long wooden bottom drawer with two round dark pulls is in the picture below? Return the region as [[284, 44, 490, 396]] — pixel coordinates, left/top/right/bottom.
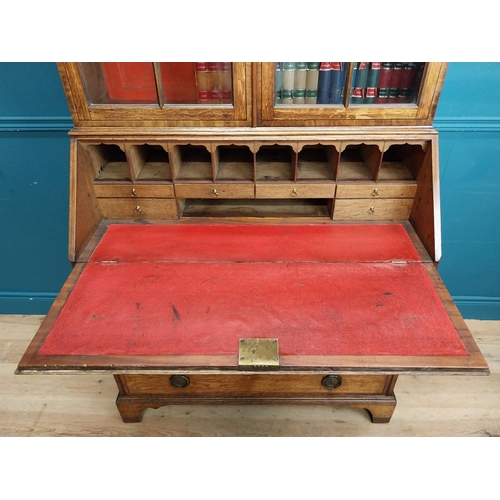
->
[[120, 372, 390, 397]]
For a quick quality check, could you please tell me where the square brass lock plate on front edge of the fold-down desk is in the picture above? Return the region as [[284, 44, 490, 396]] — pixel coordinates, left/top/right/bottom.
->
[[238, 339, 280, 371]]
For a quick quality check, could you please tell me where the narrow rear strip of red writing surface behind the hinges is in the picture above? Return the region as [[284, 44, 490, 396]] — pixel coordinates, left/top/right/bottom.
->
[[91, 224, 420, 262]]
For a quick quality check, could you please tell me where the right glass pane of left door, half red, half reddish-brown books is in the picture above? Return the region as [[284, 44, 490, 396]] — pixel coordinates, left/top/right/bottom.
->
[[160, 62, 233, 106]]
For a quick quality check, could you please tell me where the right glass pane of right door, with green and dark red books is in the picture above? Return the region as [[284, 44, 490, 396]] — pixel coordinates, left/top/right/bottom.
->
[[350, 62, 425, 105]]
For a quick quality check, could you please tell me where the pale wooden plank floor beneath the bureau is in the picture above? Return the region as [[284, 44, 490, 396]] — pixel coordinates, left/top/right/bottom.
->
[[0, 315, 500, 436]]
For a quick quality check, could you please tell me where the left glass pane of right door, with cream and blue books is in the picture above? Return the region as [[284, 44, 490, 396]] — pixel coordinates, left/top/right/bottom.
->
[[275, 62, 347, 106]]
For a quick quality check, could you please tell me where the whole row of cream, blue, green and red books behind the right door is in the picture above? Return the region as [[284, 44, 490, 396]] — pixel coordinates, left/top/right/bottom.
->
[[275, 62, 424, 104]]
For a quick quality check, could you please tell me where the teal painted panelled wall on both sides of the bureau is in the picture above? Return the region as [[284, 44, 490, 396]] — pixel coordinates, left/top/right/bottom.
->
[[0, 63, 500, 319]]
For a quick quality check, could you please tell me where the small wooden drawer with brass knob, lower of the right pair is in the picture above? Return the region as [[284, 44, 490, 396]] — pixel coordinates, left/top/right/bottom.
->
[[333, 198, 413, 221]]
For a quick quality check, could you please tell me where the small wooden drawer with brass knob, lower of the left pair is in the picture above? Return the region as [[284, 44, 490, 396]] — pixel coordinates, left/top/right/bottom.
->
[[97, 198, 178, 219]]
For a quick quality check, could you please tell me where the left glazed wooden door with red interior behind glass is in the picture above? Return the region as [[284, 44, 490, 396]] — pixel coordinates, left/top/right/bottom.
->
[[59, 62, 251, 126]]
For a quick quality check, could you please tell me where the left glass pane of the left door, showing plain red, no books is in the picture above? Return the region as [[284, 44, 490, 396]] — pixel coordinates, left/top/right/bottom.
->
[[79, 62, 158, 104]]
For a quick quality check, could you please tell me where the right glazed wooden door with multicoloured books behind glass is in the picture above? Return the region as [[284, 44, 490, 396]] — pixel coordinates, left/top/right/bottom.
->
[[257, 62, 446, 126]]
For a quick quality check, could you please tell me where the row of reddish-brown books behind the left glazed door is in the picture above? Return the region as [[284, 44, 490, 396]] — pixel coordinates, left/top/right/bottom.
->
[[194, 62, 233, 104]]
